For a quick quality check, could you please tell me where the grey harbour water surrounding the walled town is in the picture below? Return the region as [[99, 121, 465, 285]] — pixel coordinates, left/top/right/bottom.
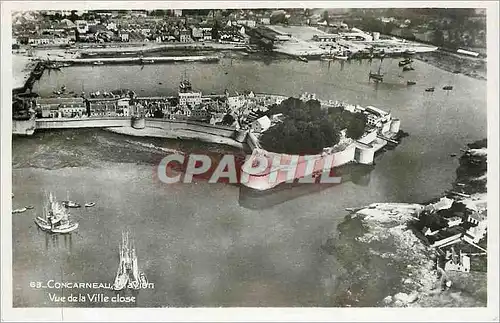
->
[[13, 58, 486, 307]]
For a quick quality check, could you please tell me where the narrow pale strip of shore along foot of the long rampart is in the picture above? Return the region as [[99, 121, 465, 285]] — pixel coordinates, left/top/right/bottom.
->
[[105, 127, 245, 149]]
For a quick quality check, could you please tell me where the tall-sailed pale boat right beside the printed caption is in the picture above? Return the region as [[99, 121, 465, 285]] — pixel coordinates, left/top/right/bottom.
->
[[113, 232, 147, 291]]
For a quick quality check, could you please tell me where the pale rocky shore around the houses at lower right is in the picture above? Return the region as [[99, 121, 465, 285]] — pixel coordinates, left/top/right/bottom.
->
[[323, 141, 487, 307]]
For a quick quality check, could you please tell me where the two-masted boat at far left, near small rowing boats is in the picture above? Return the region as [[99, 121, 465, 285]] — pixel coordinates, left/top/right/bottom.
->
[[35, 193, 79, 233]]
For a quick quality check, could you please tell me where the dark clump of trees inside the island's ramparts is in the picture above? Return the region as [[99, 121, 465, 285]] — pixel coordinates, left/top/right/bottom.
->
[[261, 98, 367, 154]]
